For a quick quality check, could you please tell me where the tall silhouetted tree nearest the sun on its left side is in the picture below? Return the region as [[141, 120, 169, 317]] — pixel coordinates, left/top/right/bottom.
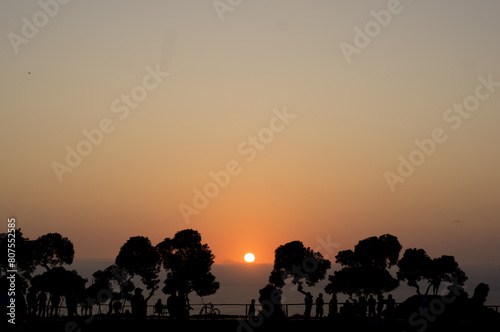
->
[[156, 229, 219, 305]]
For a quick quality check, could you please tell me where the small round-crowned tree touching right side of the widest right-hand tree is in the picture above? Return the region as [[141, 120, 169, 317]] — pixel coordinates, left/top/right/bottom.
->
[[397, 248, 432, 295]]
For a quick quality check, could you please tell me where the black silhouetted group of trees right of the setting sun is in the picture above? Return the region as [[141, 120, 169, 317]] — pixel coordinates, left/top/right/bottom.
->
[[269, 234, 467, 297]]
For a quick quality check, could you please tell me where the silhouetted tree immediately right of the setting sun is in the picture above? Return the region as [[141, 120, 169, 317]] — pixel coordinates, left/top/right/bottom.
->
[[269, 241, 331, 288]]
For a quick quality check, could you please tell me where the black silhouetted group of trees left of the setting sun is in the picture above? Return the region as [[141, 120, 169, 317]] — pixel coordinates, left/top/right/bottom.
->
[[0, 229, 219, 313]]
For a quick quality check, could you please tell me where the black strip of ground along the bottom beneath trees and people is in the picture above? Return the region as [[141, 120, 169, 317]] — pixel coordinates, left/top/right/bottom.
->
[[2, 317, 500, 332]]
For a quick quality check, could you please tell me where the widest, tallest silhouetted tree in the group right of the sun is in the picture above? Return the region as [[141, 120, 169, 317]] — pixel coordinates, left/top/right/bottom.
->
[[325, 234, 401, 297]]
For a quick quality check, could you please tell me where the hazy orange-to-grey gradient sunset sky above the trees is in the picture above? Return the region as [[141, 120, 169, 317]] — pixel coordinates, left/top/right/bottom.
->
[[0, 0, 500, 268]]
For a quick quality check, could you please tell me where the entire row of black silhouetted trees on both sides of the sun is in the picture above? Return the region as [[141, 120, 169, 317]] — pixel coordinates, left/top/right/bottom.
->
[[0, 229, 467, 313]]
